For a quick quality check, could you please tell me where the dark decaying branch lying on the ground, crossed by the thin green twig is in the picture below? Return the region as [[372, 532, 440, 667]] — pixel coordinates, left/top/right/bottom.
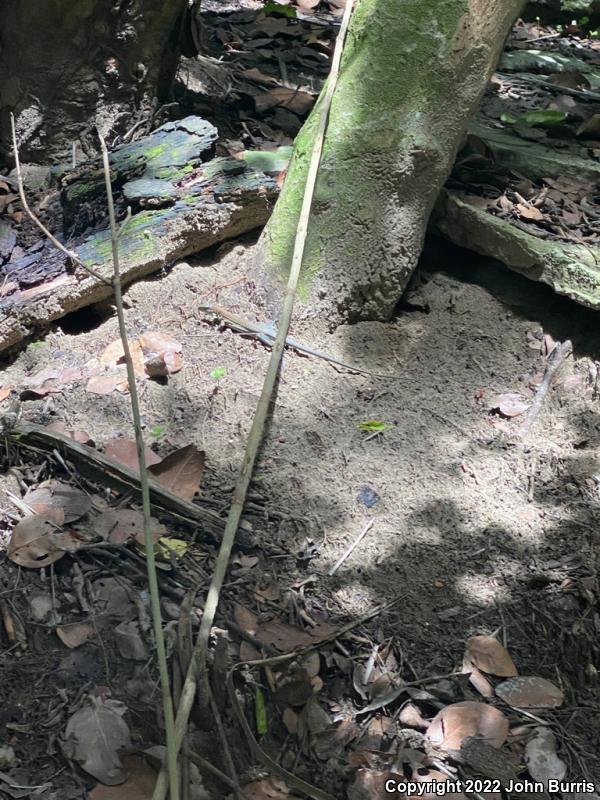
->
[[10, 422, 234, 546]]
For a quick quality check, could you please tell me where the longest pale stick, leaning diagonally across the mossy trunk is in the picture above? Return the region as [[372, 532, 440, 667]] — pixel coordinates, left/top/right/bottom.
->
[[152, 1, 353, 800]]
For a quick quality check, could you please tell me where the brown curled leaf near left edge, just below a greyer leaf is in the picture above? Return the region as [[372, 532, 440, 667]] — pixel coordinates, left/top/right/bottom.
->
[[8, 514, 83, 569]]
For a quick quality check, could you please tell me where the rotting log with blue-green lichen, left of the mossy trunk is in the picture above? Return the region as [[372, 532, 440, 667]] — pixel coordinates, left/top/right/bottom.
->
[[0, 118, 277, 351]]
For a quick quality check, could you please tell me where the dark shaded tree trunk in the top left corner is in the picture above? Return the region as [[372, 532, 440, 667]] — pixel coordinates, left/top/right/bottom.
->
[[0, 0, 187, 163]]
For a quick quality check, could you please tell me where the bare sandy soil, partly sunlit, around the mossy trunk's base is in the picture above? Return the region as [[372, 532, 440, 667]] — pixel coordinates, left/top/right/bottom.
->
[[0, 233, 600, 797]]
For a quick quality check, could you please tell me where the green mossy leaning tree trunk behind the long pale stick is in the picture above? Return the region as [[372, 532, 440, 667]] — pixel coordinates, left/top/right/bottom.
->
[[255, 0, 523, 322]]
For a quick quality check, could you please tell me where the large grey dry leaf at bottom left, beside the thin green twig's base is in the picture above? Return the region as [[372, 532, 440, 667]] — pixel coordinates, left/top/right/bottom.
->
[[63, 695, 131, 786]]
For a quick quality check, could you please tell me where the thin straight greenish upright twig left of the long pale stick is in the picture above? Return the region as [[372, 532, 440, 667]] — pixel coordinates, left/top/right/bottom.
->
[[98, 132, 179, 800]]
